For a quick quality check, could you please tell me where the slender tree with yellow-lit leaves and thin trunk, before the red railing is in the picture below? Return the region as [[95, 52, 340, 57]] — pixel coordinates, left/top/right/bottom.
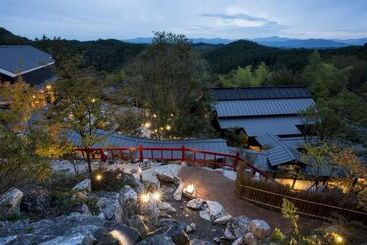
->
[[48, 57, 114, 179]]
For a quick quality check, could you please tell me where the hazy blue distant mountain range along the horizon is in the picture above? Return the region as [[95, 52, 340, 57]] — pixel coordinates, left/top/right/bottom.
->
[[123, 36, 367, 48]]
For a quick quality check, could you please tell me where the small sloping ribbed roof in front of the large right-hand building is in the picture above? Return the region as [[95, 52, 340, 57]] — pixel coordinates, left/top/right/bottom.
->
[[256, 134, 300, 167]]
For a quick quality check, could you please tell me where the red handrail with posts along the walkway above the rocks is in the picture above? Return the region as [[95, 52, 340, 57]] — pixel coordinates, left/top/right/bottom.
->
[[74, 145, 269, 179]]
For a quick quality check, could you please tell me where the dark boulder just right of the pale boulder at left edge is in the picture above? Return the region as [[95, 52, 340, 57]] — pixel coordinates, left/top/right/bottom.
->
[[20, 187, 50, 214]]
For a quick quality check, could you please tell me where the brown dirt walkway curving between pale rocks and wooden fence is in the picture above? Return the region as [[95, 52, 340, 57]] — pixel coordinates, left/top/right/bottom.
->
[[178, 167, 322, 232]]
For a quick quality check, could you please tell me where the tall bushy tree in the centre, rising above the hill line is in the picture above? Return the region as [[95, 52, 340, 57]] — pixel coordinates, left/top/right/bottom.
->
[[127, 32, 211, 138]]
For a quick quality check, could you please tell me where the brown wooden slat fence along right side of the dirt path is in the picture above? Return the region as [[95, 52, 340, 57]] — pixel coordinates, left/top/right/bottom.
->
[[235, 181, 367, 223]]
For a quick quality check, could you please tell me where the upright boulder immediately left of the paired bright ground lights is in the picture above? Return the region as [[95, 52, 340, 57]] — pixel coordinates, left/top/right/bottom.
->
[[117, 185, 138, 217]]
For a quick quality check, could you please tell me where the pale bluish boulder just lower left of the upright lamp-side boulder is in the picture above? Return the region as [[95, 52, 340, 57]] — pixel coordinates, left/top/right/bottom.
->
[[97, 197, 124, 222]]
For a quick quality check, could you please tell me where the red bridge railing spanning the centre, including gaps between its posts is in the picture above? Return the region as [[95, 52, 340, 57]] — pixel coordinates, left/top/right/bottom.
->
[[74, 145, 268, 179]]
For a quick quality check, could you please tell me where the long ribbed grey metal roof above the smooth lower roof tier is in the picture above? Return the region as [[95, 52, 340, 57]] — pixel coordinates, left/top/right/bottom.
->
[[214, 98, 315, 118]]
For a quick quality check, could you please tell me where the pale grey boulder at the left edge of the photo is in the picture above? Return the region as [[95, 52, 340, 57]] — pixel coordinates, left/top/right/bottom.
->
[[0, 188, 23, 218]]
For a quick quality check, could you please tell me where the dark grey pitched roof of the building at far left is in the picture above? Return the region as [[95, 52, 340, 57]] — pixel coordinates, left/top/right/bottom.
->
[[0, 45, 54, 77]]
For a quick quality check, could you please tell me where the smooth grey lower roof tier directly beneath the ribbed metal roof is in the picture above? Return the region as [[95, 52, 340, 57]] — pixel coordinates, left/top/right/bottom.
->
[[219, 116, 305, 137]]
